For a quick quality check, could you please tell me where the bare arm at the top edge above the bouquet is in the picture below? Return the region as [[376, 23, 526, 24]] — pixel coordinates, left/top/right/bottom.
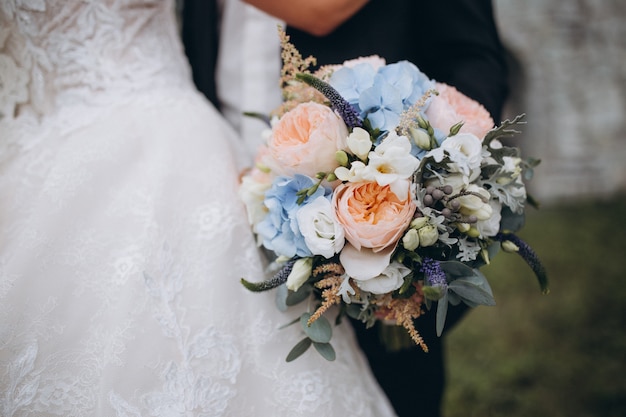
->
[[239, 0, 368, 36]]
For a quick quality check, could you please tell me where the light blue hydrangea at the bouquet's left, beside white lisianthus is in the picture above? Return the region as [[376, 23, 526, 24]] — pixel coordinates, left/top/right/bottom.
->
[[257, 174, 330, 258]]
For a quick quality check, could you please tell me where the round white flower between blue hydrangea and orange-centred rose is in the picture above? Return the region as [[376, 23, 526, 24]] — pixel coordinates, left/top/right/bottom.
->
[[296, 196, 345, 259]]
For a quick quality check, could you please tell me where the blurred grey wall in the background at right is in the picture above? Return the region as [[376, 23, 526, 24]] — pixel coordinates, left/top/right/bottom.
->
[[494, 0, 626, 204]]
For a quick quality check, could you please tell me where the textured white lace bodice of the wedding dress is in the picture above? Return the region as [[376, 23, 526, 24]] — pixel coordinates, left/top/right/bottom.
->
[[0, 0, 189, 119]]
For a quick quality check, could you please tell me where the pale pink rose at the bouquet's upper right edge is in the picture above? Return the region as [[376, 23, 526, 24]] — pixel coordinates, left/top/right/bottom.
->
[[426, 83, 494, 140]]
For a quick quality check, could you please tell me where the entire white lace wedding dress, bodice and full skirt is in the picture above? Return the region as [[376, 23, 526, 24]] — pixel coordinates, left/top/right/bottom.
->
[[0, 0, 392, 417]]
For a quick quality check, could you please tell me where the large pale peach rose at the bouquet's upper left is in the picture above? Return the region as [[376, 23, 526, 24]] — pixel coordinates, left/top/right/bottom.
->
[[265, 102, 348, 177]]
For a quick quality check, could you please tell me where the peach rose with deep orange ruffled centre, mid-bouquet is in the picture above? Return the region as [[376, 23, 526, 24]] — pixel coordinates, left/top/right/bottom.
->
[[333, 182, 416, 252]]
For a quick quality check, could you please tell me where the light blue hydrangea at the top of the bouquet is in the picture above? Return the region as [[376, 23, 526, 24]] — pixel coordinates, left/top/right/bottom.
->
[[330, 61, 434, 132]]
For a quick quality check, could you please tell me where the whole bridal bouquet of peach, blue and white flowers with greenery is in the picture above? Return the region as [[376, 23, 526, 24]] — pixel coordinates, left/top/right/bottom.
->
[[240, 33, 548, 360]]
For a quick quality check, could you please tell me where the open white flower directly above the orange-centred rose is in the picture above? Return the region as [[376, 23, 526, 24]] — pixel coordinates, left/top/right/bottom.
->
[[365, 131, 420, 201]]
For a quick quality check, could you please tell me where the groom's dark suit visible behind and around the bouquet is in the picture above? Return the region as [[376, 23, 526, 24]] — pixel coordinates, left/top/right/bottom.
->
[[183, 0, 507, 417]]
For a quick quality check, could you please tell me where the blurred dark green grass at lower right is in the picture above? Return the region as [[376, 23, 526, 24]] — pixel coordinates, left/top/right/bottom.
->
[[444, 196, 626, 417]]
